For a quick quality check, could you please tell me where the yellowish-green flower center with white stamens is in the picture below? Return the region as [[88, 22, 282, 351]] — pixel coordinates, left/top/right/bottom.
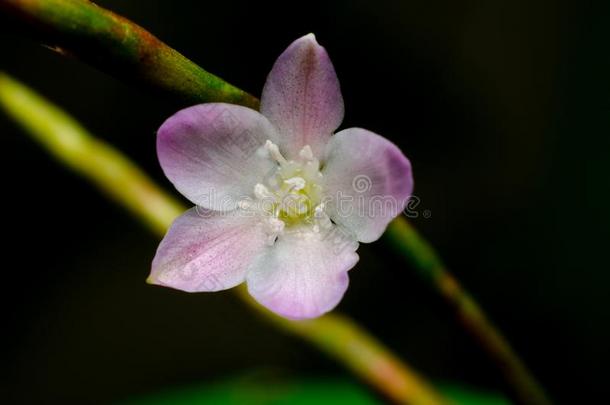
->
[[240, 140, 332, 244]]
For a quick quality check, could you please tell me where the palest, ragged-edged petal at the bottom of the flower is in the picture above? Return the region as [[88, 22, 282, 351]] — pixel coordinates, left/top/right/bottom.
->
[[247, 227, 358, 319]]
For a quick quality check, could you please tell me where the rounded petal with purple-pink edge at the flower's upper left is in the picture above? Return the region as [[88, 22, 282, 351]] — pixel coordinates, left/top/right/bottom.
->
[[157, 103, 277, 211]]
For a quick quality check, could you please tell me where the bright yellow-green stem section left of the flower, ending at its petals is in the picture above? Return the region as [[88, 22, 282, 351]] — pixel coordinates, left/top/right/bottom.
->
[[0, 72, 185, 234]]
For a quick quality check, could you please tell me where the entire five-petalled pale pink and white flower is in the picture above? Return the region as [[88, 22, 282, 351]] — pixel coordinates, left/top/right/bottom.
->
[[148, 34, 413, 319]]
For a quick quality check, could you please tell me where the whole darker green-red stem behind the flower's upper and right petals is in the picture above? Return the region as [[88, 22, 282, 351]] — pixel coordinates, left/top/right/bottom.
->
[[0, 0, 550, 405]]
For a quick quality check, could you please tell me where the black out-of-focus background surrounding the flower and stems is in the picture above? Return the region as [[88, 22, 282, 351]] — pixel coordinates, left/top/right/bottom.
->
[[0, 0, 610, 404]]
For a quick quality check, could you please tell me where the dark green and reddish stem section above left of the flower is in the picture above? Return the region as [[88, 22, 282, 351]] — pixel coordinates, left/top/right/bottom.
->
[[0, 0, 258, 108]]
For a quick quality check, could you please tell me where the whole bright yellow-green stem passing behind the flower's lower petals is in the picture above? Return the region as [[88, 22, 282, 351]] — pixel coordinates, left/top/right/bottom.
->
[[0, 73, 446, 405]]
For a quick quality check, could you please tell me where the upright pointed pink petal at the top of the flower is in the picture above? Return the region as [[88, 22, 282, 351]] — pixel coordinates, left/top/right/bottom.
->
[[261, 34, 343, 158]]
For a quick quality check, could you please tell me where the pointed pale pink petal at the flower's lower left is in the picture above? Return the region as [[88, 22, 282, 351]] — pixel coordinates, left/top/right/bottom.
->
[[148, 208, 266, 292]]
